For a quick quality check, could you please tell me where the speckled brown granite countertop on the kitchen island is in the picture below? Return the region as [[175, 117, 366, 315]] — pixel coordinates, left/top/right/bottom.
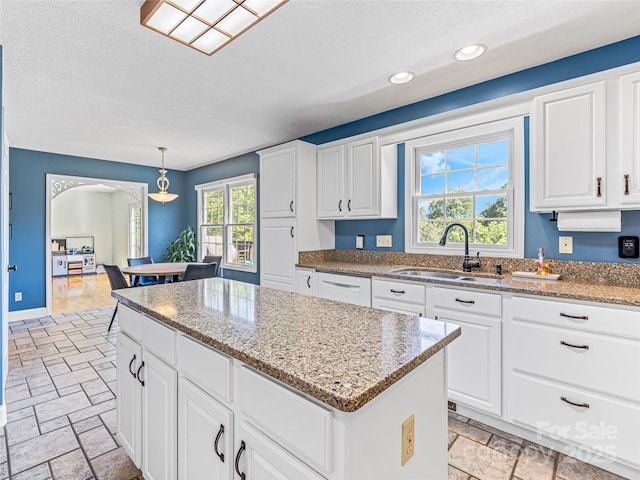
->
[[112, 278, 460, 412]]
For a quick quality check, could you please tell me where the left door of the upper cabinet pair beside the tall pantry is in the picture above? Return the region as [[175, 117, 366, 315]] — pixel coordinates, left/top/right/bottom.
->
[[317, 145, 347, 219]]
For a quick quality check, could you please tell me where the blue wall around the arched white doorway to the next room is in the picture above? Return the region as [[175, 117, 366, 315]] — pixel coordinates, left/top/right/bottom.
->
[[9, 148, 188, 311]]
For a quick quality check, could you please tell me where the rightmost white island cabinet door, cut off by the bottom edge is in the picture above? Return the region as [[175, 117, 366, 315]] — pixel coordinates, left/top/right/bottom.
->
[[236, 422, 323, 480]]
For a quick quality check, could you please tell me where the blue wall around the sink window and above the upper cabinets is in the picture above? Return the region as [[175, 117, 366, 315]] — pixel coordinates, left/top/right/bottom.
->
[[301, 36, 640, 263]]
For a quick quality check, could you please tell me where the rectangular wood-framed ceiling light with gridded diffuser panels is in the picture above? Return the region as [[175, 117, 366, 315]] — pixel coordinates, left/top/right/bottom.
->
[[140, 0, 288, 55]]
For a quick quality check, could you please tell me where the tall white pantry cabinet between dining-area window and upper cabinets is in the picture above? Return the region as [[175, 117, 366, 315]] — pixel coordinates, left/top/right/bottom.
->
[[258, 141, 335, 291]]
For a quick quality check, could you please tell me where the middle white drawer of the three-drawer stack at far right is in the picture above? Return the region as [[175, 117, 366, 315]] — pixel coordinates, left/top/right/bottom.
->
[[508, 321, 640, 402]]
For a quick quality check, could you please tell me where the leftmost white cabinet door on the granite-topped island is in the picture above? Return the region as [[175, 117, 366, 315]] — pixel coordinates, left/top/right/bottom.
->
[[116, 331, 142, 468]]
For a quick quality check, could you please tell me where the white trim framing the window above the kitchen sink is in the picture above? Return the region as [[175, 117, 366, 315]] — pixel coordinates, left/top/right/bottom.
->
[[404, 116, 525, 258]]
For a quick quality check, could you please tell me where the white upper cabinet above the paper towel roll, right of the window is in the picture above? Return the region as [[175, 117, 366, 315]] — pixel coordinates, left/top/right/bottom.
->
[[530, 68, 640, 212]]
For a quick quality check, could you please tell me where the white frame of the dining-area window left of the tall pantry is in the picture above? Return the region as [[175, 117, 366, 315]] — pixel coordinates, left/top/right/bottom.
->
[[195, 173, 259, 273]]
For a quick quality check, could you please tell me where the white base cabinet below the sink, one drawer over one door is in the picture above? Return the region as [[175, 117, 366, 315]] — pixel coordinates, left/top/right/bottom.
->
[[428, 287, 502, 416]]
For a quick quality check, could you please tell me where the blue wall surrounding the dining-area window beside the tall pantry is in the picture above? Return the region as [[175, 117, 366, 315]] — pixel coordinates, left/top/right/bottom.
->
[[185, 153, 260, 284]]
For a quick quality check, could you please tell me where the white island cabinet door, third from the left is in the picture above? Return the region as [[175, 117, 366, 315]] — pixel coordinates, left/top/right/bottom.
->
[[178, 379, 233, 480]]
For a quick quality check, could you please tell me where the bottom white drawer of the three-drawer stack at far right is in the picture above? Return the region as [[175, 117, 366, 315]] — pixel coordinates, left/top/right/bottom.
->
[[507, 374, 640, 465]]
